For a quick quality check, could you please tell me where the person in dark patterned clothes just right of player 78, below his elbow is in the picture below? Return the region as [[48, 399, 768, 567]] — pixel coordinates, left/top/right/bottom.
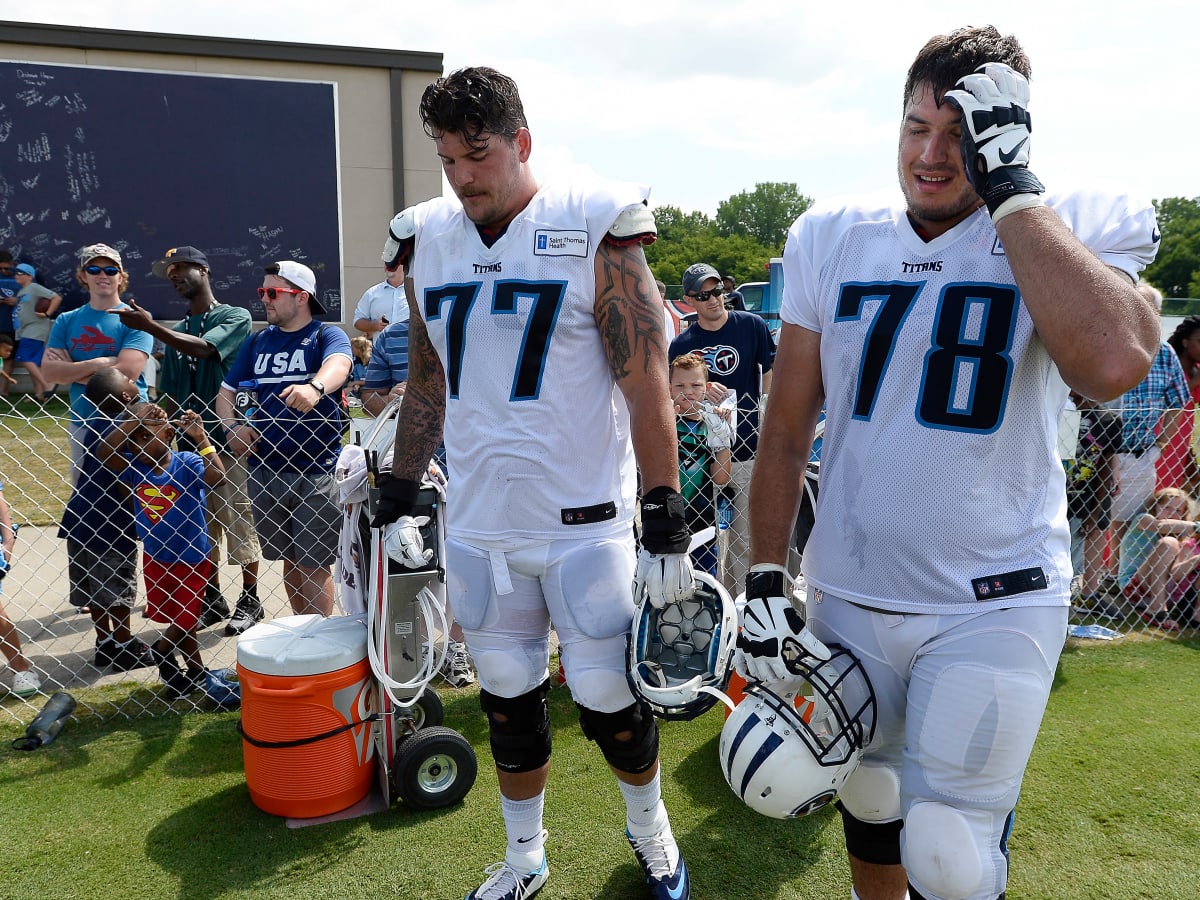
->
[[1067, 391, 1121, 619]]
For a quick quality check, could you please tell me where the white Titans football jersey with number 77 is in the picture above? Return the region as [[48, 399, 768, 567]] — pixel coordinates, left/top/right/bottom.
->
[[409, 184, 649, 542]]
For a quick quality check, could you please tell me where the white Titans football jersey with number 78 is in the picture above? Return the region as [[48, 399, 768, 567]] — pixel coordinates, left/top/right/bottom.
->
[[781, 194, 1158, 613]]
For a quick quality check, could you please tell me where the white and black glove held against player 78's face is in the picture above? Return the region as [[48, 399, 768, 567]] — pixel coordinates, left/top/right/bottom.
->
[[946, 62, 1045, 222]]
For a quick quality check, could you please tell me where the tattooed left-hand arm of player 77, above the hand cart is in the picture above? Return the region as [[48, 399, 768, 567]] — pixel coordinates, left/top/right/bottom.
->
[[391, 314, 446, 481]]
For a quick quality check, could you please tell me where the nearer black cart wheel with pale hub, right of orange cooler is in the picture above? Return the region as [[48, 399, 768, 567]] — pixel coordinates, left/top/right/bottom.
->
[[391, 725, 479, 809]]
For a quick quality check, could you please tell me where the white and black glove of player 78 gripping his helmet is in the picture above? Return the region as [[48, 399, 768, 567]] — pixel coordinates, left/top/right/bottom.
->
[[733, 563, 829, 684]]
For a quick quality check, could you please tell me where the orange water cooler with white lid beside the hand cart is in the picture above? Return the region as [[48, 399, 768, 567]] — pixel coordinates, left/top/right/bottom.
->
[[238, 616, 376, 818]]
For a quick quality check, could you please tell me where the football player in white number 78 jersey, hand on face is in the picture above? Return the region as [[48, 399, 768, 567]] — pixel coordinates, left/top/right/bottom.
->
[[738, 28, 1159, 900]]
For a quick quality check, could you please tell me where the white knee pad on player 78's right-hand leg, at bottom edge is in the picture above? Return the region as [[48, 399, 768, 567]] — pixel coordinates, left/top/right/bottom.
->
[[904, 800, 984, 898]]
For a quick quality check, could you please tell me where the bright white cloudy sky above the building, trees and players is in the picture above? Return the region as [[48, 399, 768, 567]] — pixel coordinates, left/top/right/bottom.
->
[[0, 0, 1200, 215]]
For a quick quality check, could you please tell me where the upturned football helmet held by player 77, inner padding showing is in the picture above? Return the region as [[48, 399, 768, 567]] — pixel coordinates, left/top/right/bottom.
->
[[625, 572, 738, 719]]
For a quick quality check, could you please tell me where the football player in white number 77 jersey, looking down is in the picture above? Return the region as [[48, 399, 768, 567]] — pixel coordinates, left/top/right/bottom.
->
[[372, 68, 692, 900]]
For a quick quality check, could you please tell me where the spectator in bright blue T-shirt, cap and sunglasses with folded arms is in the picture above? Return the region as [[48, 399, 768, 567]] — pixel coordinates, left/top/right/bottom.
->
[[42, 244, 154, 478]]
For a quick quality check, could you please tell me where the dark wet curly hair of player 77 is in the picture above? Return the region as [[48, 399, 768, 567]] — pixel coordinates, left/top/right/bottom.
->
[[420, 66, 528, 148]]
